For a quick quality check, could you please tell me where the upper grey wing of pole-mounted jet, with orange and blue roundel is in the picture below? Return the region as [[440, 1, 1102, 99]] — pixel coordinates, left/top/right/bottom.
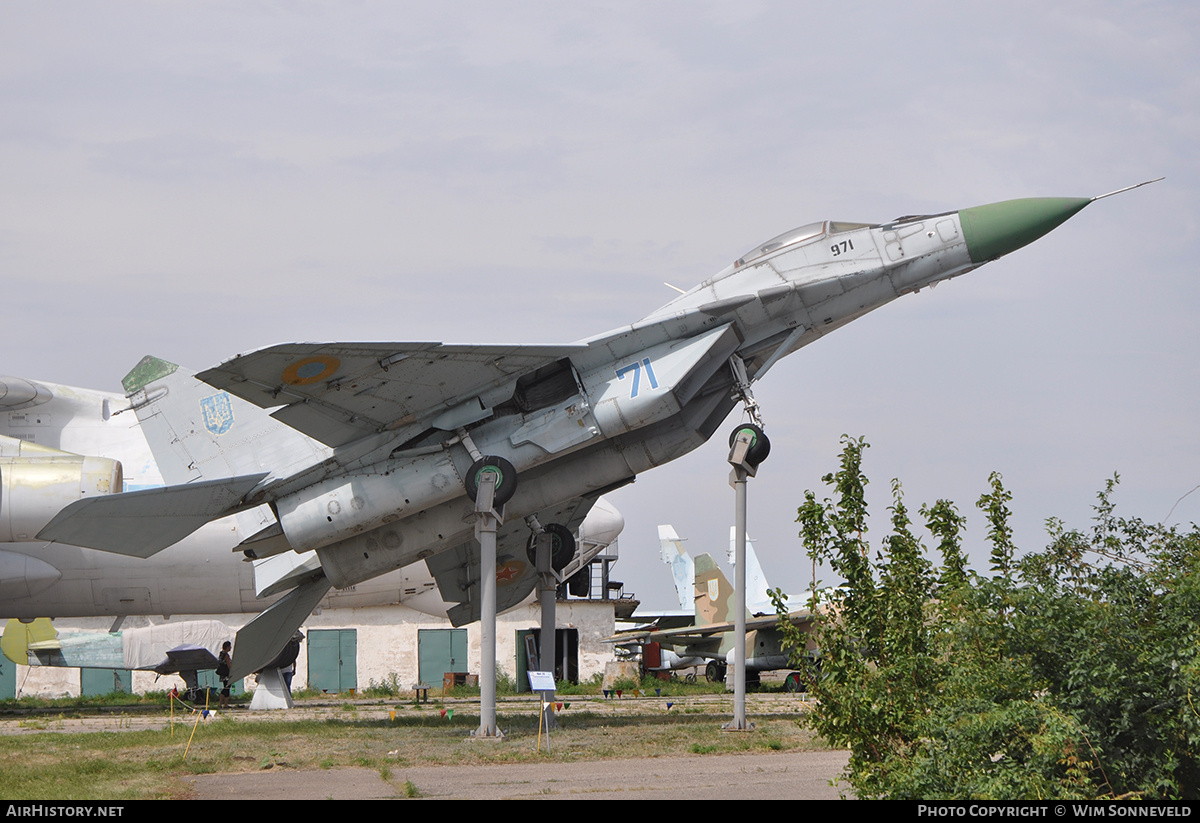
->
[[197, 343, 588, 447]]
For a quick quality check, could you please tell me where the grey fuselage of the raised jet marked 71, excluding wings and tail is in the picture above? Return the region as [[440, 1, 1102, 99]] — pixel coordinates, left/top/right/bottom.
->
[[307, 199, 1051, 585]]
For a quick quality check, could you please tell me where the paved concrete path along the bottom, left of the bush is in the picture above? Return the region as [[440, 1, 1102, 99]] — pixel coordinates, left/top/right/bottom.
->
[[188, 751, 848, 800]]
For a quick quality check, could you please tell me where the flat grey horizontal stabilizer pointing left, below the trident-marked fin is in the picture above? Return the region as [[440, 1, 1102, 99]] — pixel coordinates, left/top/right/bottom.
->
[[37, 474, 266, 557]]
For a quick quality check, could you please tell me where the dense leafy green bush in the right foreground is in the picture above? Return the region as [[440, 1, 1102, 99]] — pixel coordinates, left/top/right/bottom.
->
[[779, 438, 1200, 799]]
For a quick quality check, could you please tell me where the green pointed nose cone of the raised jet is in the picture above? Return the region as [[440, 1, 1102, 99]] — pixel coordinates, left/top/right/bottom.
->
[[959, 197, 1092, 263]]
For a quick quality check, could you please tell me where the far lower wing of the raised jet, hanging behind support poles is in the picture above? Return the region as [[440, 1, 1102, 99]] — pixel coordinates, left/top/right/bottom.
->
[[425, 498, 596, 626]]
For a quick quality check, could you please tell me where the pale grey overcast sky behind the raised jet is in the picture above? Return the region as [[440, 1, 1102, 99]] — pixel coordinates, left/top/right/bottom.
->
[[0, 0, 1200, 607]]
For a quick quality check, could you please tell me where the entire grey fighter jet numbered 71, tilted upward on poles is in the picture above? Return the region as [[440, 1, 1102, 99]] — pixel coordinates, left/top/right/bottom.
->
[[38, 184, 1144, 674]]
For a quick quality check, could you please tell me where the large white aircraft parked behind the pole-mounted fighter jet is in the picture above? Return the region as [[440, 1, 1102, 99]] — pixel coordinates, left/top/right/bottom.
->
[[0, 377, 623, 620]]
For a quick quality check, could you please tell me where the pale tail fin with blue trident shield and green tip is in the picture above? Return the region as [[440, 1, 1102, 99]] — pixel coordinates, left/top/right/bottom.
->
[[121, 355, 330, 486]]
